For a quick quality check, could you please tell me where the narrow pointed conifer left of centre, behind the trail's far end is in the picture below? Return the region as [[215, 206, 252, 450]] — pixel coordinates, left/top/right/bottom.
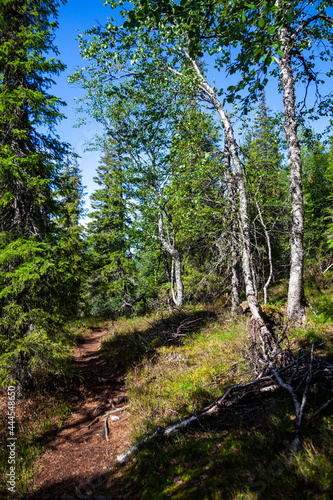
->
[[85, 139, 135, 315]]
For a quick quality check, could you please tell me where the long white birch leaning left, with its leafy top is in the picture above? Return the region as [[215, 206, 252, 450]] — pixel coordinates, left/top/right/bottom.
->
[[99, 2, 263, 324]]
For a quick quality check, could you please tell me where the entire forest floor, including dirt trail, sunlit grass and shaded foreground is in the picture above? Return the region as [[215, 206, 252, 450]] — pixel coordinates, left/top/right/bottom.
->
[[0, 287, 333, 500]]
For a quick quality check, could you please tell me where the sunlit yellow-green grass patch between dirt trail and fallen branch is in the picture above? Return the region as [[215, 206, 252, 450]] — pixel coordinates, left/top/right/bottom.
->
[[127, 312, 246, 434]]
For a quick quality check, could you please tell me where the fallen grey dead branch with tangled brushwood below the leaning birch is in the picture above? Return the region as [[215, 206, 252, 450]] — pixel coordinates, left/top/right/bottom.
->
[[117, 322, 333, 464]]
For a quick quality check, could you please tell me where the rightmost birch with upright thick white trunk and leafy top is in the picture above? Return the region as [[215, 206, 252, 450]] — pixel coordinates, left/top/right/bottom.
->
[[219, 0, 333, 322]]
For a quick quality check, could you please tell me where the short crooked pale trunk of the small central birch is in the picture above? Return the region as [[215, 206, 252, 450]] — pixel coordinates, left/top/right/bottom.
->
[[158, 212, 184, 306]]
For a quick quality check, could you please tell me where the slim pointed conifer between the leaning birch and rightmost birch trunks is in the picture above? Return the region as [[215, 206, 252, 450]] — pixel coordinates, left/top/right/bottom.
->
[[242, 93, 290, 303]]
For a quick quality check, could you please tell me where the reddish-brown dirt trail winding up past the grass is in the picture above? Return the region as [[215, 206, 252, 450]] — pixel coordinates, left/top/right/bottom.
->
[[27, 327, 131, 500]]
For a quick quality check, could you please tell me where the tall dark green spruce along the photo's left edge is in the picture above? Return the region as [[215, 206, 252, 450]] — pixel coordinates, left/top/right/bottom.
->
[[0, 0, 80, 395]]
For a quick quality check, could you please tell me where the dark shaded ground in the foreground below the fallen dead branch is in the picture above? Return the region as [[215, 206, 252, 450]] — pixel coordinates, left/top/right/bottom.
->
[[29, 393, 333, 500]]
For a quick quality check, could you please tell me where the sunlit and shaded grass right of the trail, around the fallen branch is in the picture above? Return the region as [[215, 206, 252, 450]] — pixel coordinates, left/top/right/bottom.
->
[[97, 290, 333, 500]]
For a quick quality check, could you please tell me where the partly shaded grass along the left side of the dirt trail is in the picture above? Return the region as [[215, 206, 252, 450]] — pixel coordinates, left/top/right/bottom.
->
[[0, 319, 94, 500]]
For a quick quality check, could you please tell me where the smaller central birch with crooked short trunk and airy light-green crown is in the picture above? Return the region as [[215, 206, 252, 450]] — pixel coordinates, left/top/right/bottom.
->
[[72, 58, 188, 306]]
